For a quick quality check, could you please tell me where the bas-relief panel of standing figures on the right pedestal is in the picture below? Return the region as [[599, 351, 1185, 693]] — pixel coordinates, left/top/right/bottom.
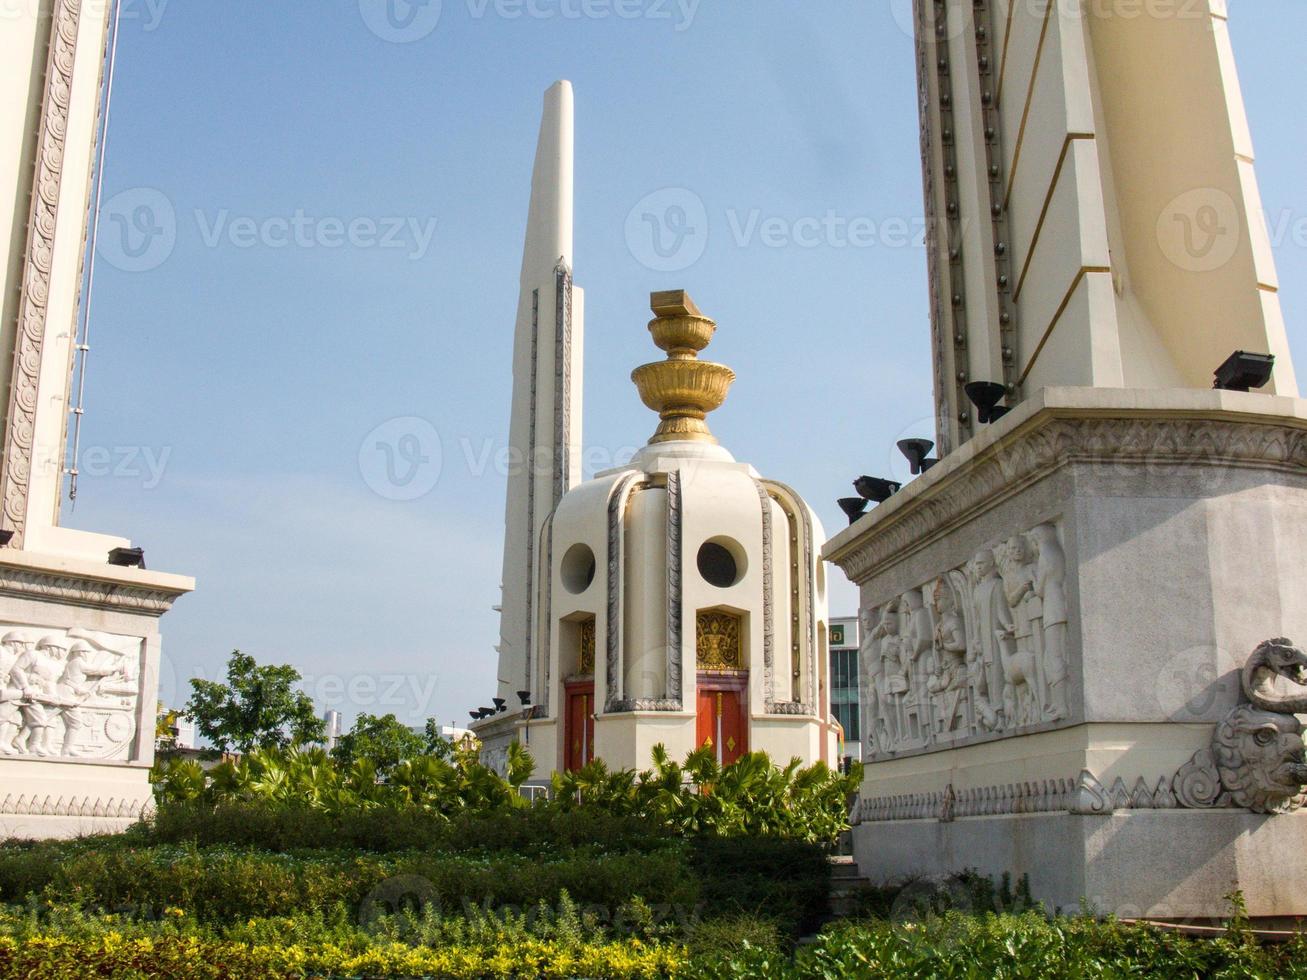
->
[[860, 524, 1069, 758]]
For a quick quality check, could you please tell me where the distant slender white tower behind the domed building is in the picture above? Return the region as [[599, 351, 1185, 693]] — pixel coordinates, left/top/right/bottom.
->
[[498, 81, 584, 707]]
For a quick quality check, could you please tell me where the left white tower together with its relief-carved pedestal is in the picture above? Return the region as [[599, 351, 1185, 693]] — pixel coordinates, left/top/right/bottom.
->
[[0, 0, 195, 838]]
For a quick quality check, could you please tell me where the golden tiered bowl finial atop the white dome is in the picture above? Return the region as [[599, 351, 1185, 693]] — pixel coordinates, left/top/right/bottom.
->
[[631, 289, 735, 444]]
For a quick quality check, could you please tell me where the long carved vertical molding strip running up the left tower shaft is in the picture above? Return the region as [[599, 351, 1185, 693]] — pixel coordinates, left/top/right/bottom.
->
[[0, 0, 81, 547]]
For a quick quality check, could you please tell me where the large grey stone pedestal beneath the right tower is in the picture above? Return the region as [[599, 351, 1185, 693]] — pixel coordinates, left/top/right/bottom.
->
[[826, 388, 1307, 917]]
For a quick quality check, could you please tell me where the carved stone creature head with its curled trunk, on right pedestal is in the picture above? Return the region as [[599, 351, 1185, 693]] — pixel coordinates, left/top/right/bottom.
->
[[1175, 638, 1307, 813]]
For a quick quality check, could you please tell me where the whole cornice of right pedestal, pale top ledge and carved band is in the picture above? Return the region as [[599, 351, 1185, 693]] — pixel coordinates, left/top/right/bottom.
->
[[823, 388, 1307, 584]]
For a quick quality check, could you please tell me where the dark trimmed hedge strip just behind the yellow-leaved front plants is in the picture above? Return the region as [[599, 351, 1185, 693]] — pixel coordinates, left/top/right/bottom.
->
[[0, 838, 830, 937]]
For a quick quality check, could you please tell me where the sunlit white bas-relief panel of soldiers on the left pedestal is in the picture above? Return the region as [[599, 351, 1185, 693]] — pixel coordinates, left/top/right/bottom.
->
[[0, 623, 142, 760]]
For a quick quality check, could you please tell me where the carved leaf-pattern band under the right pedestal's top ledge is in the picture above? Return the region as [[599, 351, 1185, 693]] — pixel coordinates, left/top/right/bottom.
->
[[830, 412, 1307, 585]]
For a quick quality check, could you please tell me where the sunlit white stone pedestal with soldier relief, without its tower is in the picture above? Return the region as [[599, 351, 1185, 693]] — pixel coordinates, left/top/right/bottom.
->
[[0, 551, 195, 839]]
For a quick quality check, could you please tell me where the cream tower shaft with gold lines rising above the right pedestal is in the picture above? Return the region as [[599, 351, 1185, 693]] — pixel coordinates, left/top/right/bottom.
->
[[915, 0, 1298, 452]]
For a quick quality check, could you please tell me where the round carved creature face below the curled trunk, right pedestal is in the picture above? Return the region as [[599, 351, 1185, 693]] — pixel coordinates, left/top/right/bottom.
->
[[1212, 704, 1307, 813]]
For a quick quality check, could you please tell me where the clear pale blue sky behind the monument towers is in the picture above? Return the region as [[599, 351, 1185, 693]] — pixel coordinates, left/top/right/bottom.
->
[[65, 0, 1307, 723]]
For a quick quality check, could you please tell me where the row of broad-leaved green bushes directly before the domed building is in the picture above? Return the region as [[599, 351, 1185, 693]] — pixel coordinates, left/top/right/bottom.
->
[[154, 742, 861, 849]]
